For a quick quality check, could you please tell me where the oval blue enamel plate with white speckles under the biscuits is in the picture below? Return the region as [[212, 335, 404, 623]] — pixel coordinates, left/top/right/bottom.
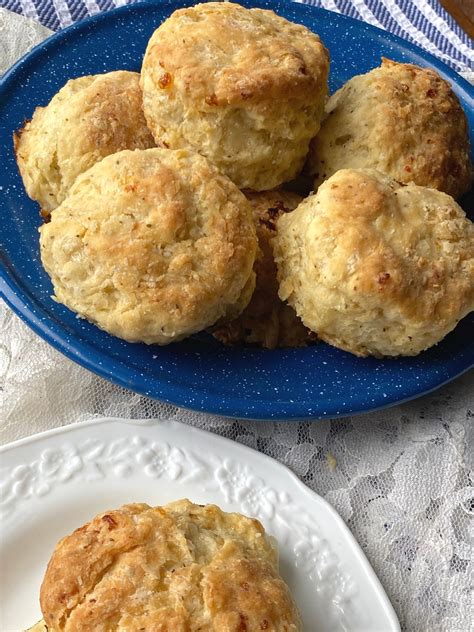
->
[[0, 1, 474, 420]]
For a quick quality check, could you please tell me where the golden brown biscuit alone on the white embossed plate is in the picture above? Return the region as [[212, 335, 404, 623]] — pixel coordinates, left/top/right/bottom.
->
[[40, 500, 301, 632]]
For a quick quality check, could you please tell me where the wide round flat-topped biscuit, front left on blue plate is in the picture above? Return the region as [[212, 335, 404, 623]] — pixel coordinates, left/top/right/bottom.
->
[[40, 149, 257, 344]]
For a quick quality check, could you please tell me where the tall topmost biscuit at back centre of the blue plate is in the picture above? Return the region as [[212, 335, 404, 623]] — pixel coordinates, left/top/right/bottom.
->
[[141, 2, 329, 191]]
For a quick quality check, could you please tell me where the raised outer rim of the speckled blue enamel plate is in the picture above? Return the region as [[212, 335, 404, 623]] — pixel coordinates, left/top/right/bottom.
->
[[0, 0, 474, 422]]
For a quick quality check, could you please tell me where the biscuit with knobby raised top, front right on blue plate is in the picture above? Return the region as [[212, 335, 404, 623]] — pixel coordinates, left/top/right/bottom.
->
[[274, 169, 474, 356]]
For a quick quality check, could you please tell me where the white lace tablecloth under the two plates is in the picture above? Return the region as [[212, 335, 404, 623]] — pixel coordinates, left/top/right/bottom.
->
[[0, 9, 474, 632]]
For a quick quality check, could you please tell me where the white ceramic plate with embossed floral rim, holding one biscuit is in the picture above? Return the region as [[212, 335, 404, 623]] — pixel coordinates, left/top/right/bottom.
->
[[0, 419, 400, 632]]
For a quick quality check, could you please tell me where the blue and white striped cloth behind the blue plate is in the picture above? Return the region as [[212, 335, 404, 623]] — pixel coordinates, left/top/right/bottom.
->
[[0, 0, 474, 78]]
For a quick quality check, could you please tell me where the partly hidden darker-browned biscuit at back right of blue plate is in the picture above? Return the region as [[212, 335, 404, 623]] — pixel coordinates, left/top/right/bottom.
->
[[308, 59, 473, 197]]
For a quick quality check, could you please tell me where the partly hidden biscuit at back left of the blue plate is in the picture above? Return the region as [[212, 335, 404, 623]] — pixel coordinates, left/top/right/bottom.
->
[[14, 70, 155, 211]]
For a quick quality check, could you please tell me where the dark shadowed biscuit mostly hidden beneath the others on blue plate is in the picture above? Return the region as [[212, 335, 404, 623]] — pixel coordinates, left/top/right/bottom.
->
[[213, 190, 315, 349]]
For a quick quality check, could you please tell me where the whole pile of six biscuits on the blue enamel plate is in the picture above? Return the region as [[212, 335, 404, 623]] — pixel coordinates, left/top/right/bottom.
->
[[15, 2, 474, 357]]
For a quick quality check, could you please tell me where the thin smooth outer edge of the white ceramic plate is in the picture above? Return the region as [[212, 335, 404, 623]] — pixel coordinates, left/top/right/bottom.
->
[[0, 417, 401, 632]]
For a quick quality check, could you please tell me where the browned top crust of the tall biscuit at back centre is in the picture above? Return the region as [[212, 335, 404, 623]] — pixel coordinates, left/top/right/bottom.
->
[[145, 2, 329, 107]]
